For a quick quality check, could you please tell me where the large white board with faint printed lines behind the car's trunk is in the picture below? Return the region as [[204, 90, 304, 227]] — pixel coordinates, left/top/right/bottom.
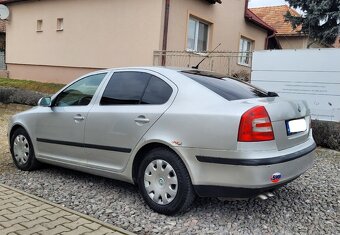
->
[[251, 48, 340, 122]]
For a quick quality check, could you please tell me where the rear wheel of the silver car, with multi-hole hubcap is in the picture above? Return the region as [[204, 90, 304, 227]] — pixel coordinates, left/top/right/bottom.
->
[[138, 148, 195, 215]]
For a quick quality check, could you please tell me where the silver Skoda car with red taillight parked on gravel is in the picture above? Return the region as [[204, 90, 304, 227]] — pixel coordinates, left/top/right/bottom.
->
[[8, 67, 316, 215]]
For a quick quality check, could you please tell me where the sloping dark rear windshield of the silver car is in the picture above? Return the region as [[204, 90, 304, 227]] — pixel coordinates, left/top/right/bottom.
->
[[180, 70, 268, 101]]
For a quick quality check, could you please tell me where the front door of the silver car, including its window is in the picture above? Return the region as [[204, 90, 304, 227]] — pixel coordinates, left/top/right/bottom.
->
[[36, 73, 106, 165]]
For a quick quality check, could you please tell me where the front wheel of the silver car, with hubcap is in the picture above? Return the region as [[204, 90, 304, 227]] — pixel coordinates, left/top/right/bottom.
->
[[10, 128, 40, 171]]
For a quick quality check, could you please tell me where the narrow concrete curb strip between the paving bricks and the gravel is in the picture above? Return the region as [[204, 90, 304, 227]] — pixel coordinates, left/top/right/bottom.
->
[[0, 184, 135, 235]]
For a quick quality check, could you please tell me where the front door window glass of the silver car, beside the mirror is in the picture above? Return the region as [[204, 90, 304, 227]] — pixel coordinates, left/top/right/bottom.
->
[[54, 73, 106, 106]]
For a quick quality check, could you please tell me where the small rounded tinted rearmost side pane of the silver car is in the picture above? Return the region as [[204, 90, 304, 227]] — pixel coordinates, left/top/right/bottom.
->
[[141, 76, 172, 104]]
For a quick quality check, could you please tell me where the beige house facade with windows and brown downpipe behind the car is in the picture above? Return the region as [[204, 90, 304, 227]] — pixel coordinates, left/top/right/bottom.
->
[[0, 0, 271, 83]]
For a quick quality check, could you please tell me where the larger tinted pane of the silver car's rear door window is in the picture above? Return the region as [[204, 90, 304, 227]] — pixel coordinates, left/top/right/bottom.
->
[[100, 72, 151, 105]]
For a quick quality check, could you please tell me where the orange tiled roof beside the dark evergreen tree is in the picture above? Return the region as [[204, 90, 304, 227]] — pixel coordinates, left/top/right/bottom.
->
[[250, 5, 301, 35]]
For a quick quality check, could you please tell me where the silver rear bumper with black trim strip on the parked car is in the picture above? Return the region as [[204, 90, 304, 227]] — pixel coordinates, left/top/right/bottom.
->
[[177, 138, 316, 198]]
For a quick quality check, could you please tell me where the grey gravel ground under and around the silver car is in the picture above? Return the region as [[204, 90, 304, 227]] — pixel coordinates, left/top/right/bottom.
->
[[0, 105, 340, 234]]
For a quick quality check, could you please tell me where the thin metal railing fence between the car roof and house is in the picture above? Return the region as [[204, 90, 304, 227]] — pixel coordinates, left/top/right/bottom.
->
[[153, 51, 252, 81]]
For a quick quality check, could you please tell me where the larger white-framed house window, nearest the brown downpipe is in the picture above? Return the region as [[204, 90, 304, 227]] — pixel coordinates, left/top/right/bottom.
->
[[187, 17, 209, 51]]
